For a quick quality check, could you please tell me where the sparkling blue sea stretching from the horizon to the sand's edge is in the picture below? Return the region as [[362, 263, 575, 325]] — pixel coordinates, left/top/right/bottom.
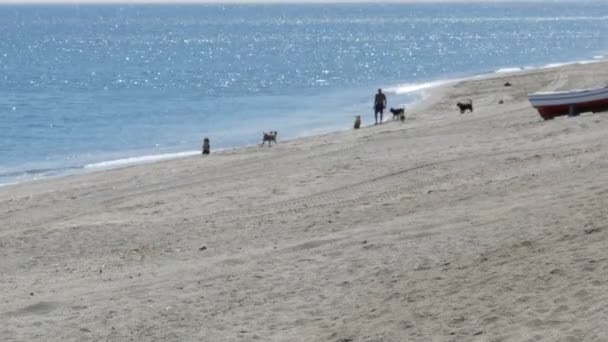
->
[[0, 2, 608, 184]]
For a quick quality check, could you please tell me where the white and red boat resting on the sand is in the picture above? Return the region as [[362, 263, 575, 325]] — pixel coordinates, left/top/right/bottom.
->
[[528, 87, 608, 120]]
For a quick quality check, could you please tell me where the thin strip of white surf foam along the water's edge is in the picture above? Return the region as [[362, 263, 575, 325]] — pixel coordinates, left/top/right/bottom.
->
[[0, 56, 607, 187]]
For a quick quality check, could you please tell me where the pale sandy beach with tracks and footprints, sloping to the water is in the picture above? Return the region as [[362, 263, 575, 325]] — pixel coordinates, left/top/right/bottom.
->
[[0, 62, 608, 342]]
